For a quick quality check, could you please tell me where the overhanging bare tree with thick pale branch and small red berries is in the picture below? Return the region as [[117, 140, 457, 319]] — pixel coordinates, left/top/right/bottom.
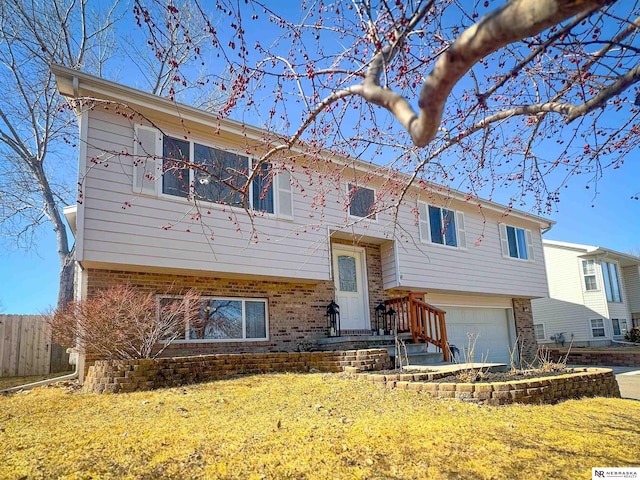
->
[[130, 0, 640, 212]]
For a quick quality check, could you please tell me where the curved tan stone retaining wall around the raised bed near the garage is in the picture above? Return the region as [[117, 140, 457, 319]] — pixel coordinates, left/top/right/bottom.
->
[[356, 368, 620, 405]]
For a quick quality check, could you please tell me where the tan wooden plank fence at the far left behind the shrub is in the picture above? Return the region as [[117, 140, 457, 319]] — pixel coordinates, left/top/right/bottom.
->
[[0, 315, 71, 377]]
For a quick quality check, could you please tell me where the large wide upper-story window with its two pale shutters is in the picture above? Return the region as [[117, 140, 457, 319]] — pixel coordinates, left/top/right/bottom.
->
[[133, 125, 293, 218]]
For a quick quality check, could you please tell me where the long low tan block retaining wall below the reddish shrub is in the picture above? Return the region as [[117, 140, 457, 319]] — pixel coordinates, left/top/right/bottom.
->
[[84, 349, 390, 393]]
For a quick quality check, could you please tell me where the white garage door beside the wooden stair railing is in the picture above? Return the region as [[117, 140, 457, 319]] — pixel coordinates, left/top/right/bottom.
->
[[440, 306, 511, 364]]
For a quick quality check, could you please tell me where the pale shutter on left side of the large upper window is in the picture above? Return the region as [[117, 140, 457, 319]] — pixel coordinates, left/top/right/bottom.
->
[[133, 125, 162, 195]]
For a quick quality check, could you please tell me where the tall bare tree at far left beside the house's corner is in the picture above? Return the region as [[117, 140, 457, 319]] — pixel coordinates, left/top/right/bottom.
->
[[0, 0, 122, 304]]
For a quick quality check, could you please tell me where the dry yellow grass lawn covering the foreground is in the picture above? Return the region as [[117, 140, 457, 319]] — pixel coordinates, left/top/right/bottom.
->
[[0, 374, 640, 479]]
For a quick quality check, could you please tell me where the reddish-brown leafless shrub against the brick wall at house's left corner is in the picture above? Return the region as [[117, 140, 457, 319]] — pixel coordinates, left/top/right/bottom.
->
[[45, 285, 201, 360]]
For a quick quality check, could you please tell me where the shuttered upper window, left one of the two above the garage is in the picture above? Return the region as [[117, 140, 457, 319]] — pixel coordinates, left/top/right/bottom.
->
[[418, 202, 467, 248]]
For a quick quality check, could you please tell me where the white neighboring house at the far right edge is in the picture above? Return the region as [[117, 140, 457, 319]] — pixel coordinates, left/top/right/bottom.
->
[[532, 240, 640, 346]]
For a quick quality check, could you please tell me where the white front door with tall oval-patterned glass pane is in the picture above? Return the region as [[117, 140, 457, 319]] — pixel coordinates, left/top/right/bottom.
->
[[333, 246, 371, 330]]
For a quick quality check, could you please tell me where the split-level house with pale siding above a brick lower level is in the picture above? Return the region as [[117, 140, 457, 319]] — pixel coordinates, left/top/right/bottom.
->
[[53, 66, 553, 378]]
